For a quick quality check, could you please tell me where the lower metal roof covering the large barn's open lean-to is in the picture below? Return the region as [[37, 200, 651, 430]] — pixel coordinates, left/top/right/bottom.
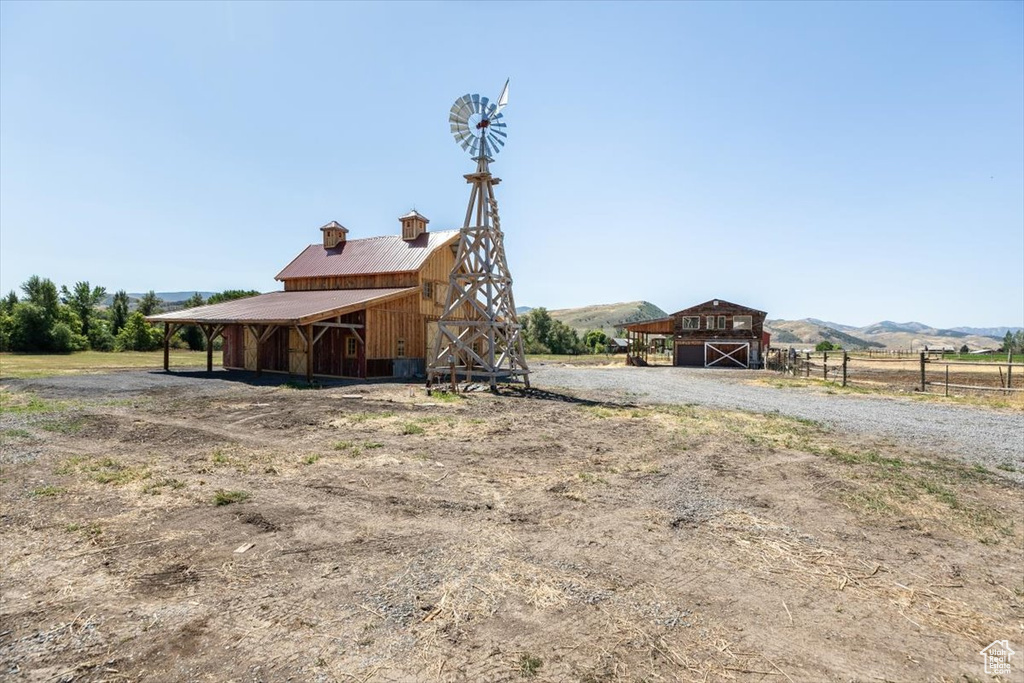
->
[[145, 287, 418, 326]]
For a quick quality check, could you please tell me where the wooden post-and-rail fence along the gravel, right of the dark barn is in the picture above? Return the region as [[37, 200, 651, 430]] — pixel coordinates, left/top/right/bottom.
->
[[765, 349, 1024, 396]]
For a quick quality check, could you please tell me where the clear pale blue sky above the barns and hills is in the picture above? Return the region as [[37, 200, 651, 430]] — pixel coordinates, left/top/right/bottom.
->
[[0, 2, 1024, 326]]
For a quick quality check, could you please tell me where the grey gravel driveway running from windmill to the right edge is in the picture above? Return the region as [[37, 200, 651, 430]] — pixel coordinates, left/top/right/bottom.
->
[[530, 364, 1024, 481]]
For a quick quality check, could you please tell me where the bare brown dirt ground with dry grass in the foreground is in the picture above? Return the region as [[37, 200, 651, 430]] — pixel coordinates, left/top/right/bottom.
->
[[0, 382, 1024, 683]]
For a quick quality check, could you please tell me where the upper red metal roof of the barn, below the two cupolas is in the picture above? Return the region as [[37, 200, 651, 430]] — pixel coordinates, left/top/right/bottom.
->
[[275, 230, 459, 281]]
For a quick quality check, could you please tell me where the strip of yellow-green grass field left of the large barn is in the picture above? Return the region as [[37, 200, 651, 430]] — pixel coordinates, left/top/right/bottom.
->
[[0, 349, 221, 379]]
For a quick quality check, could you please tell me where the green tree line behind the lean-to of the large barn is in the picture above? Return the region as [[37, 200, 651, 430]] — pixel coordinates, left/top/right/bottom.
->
[[0, 275, 259, 353]]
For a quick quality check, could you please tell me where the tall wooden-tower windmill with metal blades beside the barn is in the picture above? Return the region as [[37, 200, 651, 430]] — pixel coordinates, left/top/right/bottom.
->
[[427, 81, 529, 389]]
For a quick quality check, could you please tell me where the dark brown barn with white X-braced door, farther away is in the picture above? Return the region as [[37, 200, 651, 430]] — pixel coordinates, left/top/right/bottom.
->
[[626, 299, 769, 368]]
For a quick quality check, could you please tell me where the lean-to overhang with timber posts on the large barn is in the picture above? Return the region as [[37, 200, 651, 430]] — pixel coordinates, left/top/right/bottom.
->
[[145, 287, 418, 381]]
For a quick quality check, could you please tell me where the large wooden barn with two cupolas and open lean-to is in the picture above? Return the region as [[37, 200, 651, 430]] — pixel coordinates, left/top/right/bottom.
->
[[146, 211, 459, 379]]
